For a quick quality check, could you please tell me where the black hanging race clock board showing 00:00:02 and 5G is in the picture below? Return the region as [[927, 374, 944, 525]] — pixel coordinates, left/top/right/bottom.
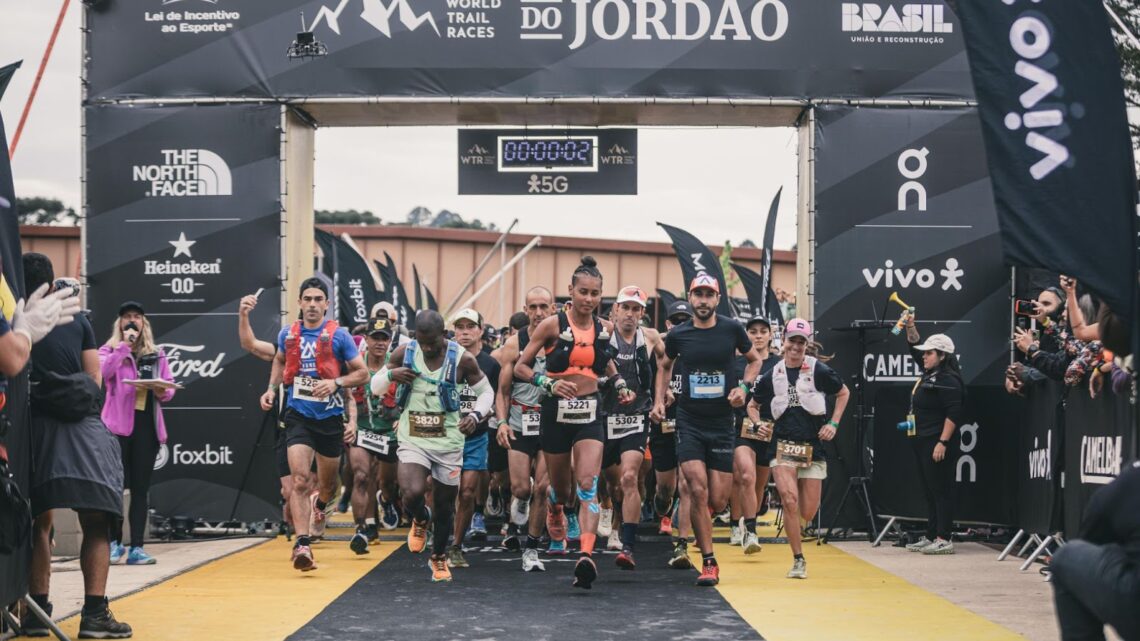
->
[[458, 129, 637, 191]]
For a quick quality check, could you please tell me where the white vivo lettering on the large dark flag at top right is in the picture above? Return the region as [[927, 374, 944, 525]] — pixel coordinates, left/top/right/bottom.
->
[[1004, 8, 1080, 180]]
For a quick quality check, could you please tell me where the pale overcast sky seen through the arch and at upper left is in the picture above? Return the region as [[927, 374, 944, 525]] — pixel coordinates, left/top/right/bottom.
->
[[0, 0, 796, 249]]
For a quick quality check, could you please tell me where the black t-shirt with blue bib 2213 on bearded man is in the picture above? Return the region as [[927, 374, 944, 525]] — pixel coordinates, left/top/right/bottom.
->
[[665, 314, 752, 419]]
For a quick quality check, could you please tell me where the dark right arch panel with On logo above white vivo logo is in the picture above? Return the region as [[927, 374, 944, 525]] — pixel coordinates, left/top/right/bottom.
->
[[814, 107, 1012, 525]]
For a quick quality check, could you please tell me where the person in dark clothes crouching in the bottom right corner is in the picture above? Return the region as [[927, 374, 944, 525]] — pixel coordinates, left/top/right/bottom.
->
[[1049, 461, 1140, 641]]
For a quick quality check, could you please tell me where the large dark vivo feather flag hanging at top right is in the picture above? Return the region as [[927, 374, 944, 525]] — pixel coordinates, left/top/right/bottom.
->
[[958, 0, 1138, 323]]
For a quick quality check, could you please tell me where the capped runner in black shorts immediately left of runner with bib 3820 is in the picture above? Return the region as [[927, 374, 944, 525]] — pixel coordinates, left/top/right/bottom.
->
[[348, 317, 399, 554]]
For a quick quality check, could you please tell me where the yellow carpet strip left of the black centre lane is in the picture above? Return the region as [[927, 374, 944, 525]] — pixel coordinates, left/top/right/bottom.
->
[[60, 530, 406, 641]]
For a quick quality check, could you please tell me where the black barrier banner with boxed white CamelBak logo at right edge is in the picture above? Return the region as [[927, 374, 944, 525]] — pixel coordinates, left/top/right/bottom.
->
[[1065, 384, 1137, 538]]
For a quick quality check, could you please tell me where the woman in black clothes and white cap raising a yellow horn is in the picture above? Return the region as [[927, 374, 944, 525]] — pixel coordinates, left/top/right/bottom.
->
[[906, 315, 966, 554]]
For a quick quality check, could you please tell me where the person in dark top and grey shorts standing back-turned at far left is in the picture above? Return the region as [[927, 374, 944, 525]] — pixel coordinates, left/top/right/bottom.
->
[[21, 253, 131, 639]]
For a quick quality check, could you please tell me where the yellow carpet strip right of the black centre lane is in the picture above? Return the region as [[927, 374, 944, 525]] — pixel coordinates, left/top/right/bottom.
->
[[711, 528, 1024, 641]]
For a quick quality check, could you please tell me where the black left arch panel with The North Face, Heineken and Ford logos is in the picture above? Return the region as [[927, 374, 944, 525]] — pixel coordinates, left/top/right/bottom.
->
[[84, 103, 280, 520]]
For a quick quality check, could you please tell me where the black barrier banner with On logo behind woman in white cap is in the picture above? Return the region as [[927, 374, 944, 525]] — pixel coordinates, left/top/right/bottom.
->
[[866, 386, 1018, 525]]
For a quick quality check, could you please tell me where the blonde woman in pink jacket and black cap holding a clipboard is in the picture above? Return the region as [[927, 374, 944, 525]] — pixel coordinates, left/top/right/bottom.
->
[[99, 301, 174, 566]]
